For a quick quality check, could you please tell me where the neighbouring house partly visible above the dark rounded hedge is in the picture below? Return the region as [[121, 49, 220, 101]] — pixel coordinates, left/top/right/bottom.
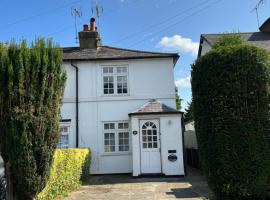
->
[[198, 18, 270, 57]]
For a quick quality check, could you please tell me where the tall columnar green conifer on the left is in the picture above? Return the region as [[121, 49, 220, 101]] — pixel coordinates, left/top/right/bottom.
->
[[0, 39, 66, 200]]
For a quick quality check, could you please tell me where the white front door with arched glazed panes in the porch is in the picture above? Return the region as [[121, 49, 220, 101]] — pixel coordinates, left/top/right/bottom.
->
[[140, 119, 161, 174]]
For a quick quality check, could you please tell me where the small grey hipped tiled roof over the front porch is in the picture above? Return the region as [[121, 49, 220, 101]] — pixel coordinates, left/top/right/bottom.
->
[[129, 99, 182, 115]]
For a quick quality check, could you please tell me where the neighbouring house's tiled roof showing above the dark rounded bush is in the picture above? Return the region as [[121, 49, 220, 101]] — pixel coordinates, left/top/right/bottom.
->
[[202, 32, 270, 50]]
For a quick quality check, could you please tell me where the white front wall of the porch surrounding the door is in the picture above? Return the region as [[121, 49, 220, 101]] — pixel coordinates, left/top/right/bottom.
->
[[132, 114, 185, 176]]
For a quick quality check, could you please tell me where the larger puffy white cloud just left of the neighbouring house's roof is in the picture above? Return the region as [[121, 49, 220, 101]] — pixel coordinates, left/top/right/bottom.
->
[[158, 35, 199, 56]]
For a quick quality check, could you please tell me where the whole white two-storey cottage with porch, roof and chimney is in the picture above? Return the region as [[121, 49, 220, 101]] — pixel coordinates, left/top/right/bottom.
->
[[59, 18, 184, 176]]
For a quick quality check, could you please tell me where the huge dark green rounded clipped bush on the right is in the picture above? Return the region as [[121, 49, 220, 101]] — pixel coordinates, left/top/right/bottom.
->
[[192, 41, 270, 199]]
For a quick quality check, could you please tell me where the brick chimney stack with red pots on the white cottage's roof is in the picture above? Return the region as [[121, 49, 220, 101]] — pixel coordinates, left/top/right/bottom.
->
[[79, 18, 101, 49]]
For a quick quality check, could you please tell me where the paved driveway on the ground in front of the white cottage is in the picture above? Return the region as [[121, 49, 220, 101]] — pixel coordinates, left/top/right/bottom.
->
[[63, 171, 210, 200]]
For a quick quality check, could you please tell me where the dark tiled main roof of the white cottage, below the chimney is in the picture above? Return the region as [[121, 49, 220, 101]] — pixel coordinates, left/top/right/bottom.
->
[[63, 46, 179, 62]]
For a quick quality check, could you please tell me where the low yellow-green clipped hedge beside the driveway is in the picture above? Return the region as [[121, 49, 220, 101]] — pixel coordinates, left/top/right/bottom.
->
[[38, 149, 91, 200]]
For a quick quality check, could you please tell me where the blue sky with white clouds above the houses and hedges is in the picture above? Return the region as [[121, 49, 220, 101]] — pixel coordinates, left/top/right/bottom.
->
[[0, 0, 270, 110]]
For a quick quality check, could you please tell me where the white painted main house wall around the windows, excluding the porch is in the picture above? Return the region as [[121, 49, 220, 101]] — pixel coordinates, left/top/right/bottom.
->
[[61, 58, 179, 174]]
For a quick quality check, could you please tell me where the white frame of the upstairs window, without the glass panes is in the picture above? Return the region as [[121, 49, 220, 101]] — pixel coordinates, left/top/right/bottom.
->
[[102, 64, 129, 96]]
